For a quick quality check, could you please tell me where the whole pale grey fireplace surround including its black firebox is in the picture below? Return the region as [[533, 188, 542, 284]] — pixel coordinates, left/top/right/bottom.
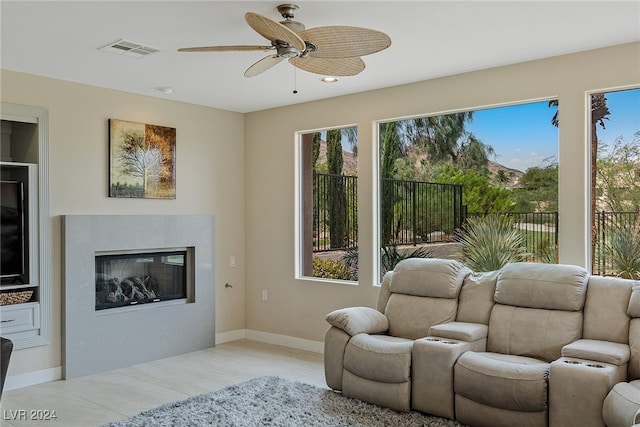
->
[[62, 215, 215, 379]]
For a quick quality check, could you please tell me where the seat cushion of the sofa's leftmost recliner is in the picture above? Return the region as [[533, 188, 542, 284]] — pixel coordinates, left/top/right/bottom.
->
[[344, 334, 413, 383]]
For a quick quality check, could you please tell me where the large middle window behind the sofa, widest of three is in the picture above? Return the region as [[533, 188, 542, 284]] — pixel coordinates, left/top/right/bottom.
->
[[378, 100, 558, 277]]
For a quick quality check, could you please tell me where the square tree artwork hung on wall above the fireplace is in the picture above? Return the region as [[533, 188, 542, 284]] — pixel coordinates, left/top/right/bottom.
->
[[109, 119, 176, 199]]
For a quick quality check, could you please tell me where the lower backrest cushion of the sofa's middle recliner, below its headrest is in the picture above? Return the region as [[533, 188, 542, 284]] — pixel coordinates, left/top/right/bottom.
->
[[487, 304, 582, 362]]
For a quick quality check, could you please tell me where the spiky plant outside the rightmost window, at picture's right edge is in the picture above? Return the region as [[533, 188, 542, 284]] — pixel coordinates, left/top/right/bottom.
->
[[604, 221, 640, 279]]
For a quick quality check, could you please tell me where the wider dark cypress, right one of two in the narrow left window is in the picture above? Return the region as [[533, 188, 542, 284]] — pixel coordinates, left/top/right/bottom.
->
[[327, 129, 347, 248]]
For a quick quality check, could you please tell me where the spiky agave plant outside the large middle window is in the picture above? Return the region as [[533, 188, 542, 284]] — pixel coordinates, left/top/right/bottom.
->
[[456, 215, 529, 272]]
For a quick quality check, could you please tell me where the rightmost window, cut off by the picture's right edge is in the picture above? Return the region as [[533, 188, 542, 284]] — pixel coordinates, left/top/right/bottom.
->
[[590, 89, 640, 279]]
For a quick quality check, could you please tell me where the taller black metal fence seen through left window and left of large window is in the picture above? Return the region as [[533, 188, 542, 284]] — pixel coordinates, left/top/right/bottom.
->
[[313, 173, 464, 252]]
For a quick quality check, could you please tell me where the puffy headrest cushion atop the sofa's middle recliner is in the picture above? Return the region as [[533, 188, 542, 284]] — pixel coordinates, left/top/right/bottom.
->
[[494, 262, 589, 311]]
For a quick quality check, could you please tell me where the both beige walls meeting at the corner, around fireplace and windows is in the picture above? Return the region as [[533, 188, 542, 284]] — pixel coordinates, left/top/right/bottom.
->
[[1, 43, 640, 375]]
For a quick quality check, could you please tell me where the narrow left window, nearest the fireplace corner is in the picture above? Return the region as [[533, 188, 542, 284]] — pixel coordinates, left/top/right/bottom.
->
[[297, 127, 358, 281]]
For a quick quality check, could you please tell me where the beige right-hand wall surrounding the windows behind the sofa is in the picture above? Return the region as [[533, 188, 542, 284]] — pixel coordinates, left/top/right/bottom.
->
[[245, 43, 640, 341]]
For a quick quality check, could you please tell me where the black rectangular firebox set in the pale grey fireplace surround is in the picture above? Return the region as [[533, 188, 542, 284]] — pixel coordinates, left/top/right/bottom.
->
[[95, 248, 189, 310]]
